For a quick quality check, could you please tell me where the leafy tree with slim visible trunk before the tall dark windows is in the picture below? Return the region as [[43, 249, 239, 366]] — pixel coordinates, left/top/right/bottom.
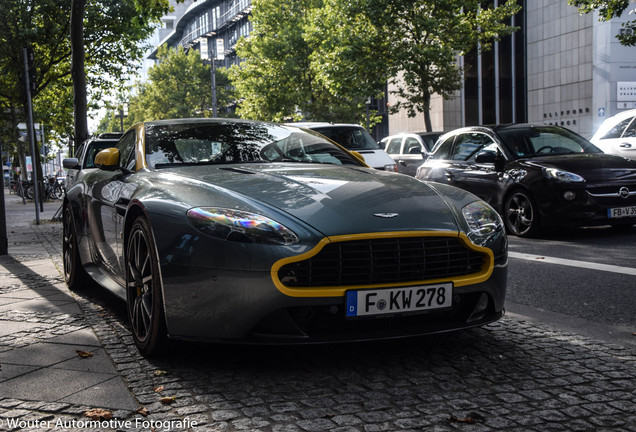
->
[[360, 0, 520, 131]]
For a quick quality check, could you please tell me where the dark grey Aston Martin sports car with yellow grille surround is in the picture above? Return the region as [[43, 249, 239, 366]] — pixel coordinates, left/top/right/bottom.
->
[[63, 119, 507, 355]]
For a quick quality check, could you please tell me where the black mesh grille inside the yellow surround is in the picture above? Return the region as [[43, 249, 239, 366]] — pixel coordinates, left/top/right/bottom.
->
[[278, 237, 486, 287]]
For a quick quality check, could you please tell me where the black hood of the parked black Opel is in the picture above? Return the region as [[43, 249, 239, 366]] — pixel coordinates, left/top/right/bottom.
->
[[524, 153, 636, 181]]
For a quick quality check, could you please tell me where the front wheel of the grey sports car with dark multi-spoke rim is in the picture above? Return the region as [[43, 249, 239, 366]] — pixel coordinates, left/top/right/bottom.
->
[[125, 217, 167, 356]]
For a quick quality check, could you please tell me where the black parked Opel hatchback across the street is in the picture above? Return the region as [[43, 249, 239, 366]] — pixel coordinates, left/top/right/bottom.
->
[[416, 124, 636, 236]]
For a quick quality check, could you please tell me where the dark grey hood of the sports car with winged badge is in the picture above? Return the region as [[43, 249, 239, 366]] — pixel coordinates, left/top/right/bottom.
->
[[165, 164, 458, 236]]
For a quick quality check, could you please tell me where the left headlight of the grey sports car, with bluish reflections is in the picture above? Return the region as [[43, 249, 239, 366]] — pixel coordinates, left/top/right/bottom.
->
[[187, 207, 298, 245]]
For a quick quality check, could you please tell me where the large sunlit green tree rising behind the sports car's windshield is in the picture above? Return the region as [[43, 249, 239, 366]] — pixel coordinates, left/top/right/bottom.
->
[[230, 0, 386, 122]]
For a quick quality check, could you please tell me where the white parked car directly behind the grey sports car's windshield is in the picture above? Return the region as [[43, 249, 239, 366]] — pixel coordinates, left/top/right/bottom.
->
[[288, 122, 397, 172]]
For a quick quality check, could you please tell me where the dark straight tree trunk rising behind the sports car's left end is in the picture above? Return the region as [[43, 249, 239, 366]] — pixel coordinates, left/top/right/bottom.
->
[[71, 0, 88, 149]]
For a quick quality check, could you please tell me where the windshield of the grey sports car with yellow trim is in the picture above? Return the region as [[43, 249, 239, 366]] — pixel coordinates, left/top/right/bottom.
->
[[146, 122, 360, 169]]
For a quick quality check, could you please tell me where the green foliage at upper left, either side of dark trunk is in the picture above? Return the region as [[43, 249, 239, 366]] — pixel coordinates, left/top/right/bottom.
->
[[0, 0, 174, 158]]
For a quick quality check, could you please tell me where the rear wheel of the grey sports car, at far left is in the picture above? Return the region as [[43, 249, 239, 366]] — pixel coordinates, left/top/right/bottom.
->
[[62, 205, 92, 291]]
